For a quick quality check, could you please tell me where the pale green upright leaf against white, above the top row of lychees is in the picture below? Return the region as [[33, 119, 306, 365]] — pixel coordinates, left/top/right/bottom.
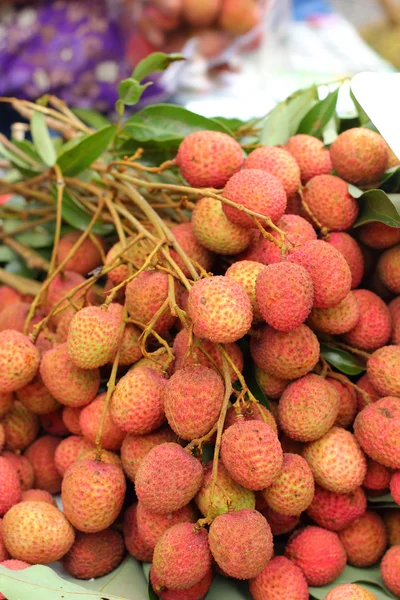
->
[[260, 85, 317, 146]]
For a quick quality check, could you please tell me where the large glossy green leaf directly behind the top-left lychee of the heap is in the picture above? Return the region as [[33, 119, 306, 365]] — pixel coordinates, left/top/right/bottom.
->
[[124, 104, 232, 148]]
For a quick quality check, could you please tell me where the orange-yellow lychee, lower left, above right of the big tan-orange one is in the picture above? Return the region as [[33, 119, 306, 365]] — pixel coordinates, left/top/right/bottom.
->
[[61, 460, 126, 533]]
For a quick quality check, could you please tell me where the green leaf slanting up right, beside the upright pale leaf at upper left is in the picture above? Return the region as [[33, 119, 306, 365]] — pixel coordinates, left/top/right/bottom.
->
[[57, 125, 116, 177]]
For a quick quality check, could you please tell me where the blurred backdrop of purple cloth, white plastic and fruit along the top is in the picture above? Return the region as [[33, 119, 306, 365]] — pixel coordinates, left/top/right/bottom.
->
[[0, 0, 400, 126]]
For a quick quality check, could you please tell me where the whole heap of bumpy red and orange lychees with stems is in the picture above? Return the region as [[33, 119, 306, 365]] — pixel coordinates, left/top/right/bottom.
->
[[0, 123, 400, 600]]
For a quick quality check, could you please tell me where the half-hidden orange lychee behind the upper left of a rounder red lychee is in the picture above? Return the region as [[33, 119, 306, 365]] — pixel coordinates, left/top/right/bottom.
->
[[121, 427, 177, 482]]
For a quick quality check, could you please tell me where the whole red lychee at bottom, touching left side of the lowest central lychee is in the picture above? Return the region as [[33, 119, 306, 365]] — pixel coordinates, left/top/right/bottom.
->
[[153, 523, 211, 590]]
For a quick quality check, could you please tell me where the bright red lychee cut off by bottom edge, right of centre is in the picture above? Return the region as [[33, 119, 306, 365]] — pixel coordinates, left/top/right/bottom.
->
[[249, 556, 309, 600]]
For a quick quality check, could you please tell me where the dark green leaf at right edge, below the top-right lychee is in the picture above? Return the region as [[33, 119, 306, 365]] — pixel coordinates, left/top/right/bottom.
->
[[353, 190, 400, 227]]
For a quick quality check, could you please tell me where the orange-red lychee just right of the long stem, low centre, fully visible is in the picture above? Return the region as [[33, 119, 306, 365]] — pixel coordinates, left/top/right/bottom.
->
[[221, 421, 283, 490]]
